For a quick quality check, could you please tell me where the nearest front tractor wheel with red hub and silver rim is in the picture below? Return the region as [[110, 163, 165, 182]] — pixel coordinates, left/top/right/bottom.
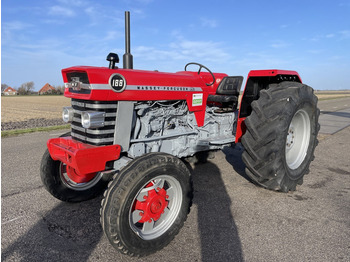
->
[[101, 153, 192, 256]]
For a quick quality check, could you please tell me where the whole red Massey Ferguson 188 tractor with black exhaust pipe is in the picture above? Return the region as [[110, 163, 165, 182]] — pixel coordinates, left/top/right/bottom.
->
[[41, 12, 320, 256]]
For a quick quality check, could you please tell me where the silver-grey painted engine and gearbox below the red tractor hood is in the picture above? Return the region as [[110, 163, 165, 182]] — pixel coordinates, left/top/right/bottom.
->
[[128, 101, 236, 158]]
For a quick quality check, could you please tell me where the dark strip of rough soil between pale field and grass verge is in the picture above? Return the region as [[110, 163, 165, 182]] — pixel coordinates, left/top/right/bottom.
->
[[1, 118, 66, 131]]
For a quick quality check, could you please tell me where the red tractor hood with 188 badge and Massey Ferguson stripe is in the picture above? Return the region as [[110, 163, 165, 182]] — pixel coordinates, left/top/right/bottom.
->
[[62, 66, 227, 101]]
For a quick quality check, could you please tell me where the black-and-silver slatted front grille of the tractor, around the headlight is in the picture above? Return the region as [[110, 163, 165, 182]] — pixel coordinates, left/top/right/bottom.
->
[[71, 99, 118, 146]]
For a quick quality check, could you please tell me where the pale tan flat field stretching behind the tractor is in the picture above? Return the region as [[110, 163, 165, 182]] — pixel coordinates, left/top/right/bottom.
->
[[1, 90, 350, 123]]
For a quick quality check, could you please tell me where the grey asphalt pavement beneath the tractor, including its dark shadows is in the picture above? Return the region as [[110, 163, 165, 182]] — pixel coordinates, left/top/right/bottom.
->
[[1, 101, 350, 262]]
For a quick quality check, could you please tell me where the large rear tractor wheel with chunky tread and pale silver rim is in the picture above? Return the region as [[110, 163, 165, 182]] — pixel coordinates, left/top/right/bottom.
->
[[242, 82, 320, 192]]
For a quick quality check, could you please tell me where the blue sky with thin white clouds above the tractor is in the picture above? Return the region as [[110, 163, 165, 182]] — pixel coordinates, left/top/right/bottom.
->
[[1, 0, 350, 90]]
